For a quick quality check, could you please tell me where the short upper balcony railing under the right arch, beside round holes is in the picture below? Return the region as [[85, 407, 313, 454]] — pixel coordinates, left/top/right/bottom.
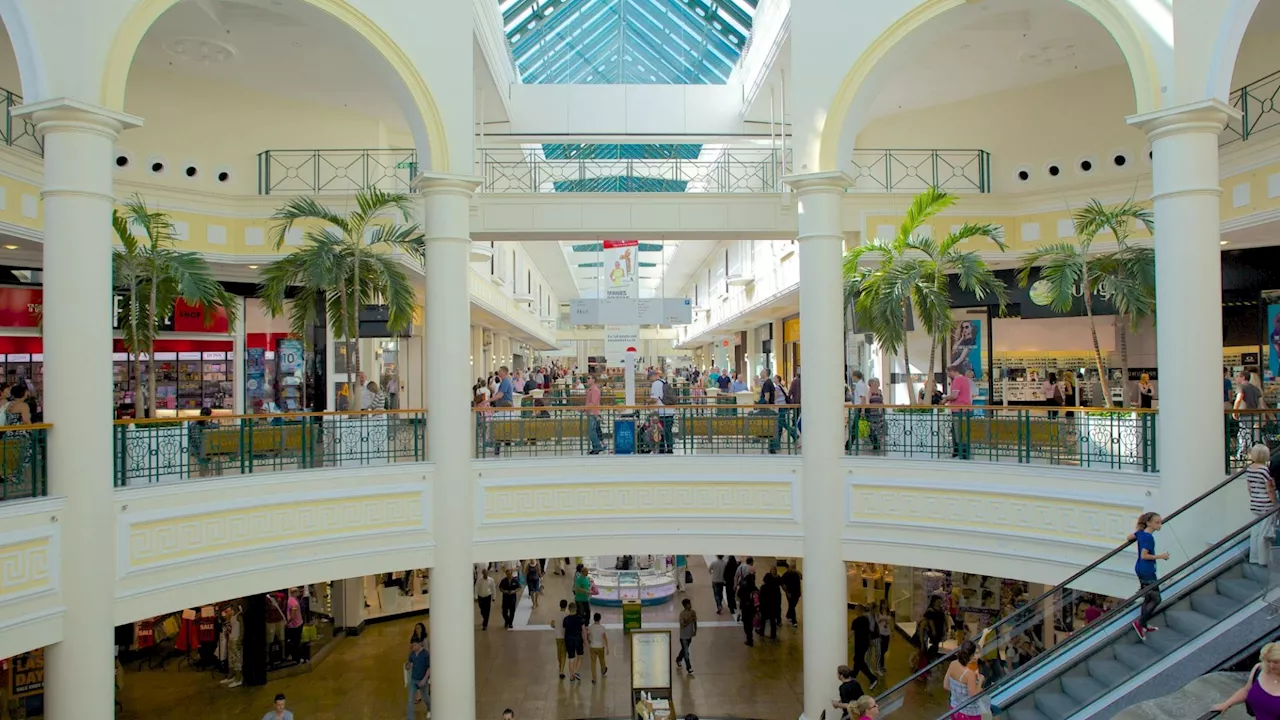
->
[[849, 150, 991, 192]]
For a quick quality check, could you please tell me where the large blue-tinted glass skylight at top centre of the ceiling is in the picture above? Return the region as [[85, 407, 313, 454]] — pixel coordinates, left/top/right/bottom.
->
[[498, 0, 759, 85]]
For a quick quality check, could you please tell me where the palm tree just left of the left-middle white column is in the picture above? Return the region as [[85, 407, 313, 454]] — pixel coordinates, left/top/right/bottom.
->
[[262, 188, 422, 407]]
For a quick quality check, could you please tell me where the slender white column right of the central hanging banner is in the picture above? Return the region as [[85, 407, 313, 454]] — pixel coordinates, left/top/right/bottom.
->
[[785, 172, 852, 720]]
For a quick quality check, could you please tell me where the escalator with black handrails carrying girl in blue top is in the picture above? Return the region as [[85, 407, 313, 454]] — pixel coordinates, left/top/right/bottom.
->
[[878, 473, 1266, 720]]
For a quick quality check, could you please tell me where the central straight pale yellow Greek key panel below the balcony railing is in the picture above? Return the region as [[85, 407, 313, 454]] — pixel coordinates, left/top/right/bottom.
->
[[480, 480, 795, 525]]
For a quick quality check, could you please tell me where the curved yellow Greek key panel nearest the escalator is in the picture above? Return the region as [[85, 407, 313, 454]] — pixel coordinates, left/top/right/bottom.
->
[[847, 482, 1142, 543]]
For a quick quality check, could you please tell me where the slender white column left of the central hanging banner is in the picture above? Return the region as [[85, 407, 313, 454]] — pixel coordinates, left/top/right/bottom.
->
[[416, 169, 481, 720]]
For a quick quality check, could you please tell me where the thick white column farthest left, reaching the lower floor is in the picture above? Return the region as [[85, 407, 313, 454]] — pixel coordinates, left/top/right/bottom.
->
[[14, 97, 142, 720]]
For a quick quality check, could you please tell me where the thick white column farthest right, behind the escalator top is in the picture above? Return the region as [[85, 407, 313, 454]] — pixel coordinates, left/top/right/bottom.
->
[[1129, 100, 1235, 504]]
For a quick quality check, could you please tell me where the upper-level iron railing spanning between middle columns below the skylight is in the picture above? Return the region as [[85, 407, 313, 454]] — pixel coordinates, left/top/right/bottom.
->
[[479, 147, 783, 193]]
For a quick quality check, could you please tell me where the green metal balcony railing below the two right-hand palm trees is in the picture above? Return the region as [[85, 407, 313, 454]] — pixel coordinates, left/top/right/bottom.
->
[[845, 405, 1156, 473]]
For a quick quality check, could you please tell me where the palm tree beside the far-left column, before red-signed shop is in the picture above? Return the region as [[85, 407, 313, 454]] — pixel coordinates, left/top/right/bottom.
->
[[111, 195, 238, 418]]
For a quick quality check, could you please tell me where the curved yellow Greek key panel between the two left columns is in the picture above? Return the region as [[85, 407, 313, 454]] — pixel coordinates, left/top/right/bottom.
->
[[129, 491, 428, 574]]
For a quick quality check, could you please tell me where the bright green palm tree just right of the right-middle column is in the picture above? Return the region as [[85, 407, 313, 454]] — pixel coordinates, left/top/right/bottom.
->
[[844, 187, 1009, 401]]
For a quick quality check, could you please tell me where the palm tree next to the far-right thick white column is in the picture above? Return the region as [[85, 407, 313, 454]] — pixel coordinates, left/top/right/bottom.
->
[[1018, 199, 1156, 407]]
